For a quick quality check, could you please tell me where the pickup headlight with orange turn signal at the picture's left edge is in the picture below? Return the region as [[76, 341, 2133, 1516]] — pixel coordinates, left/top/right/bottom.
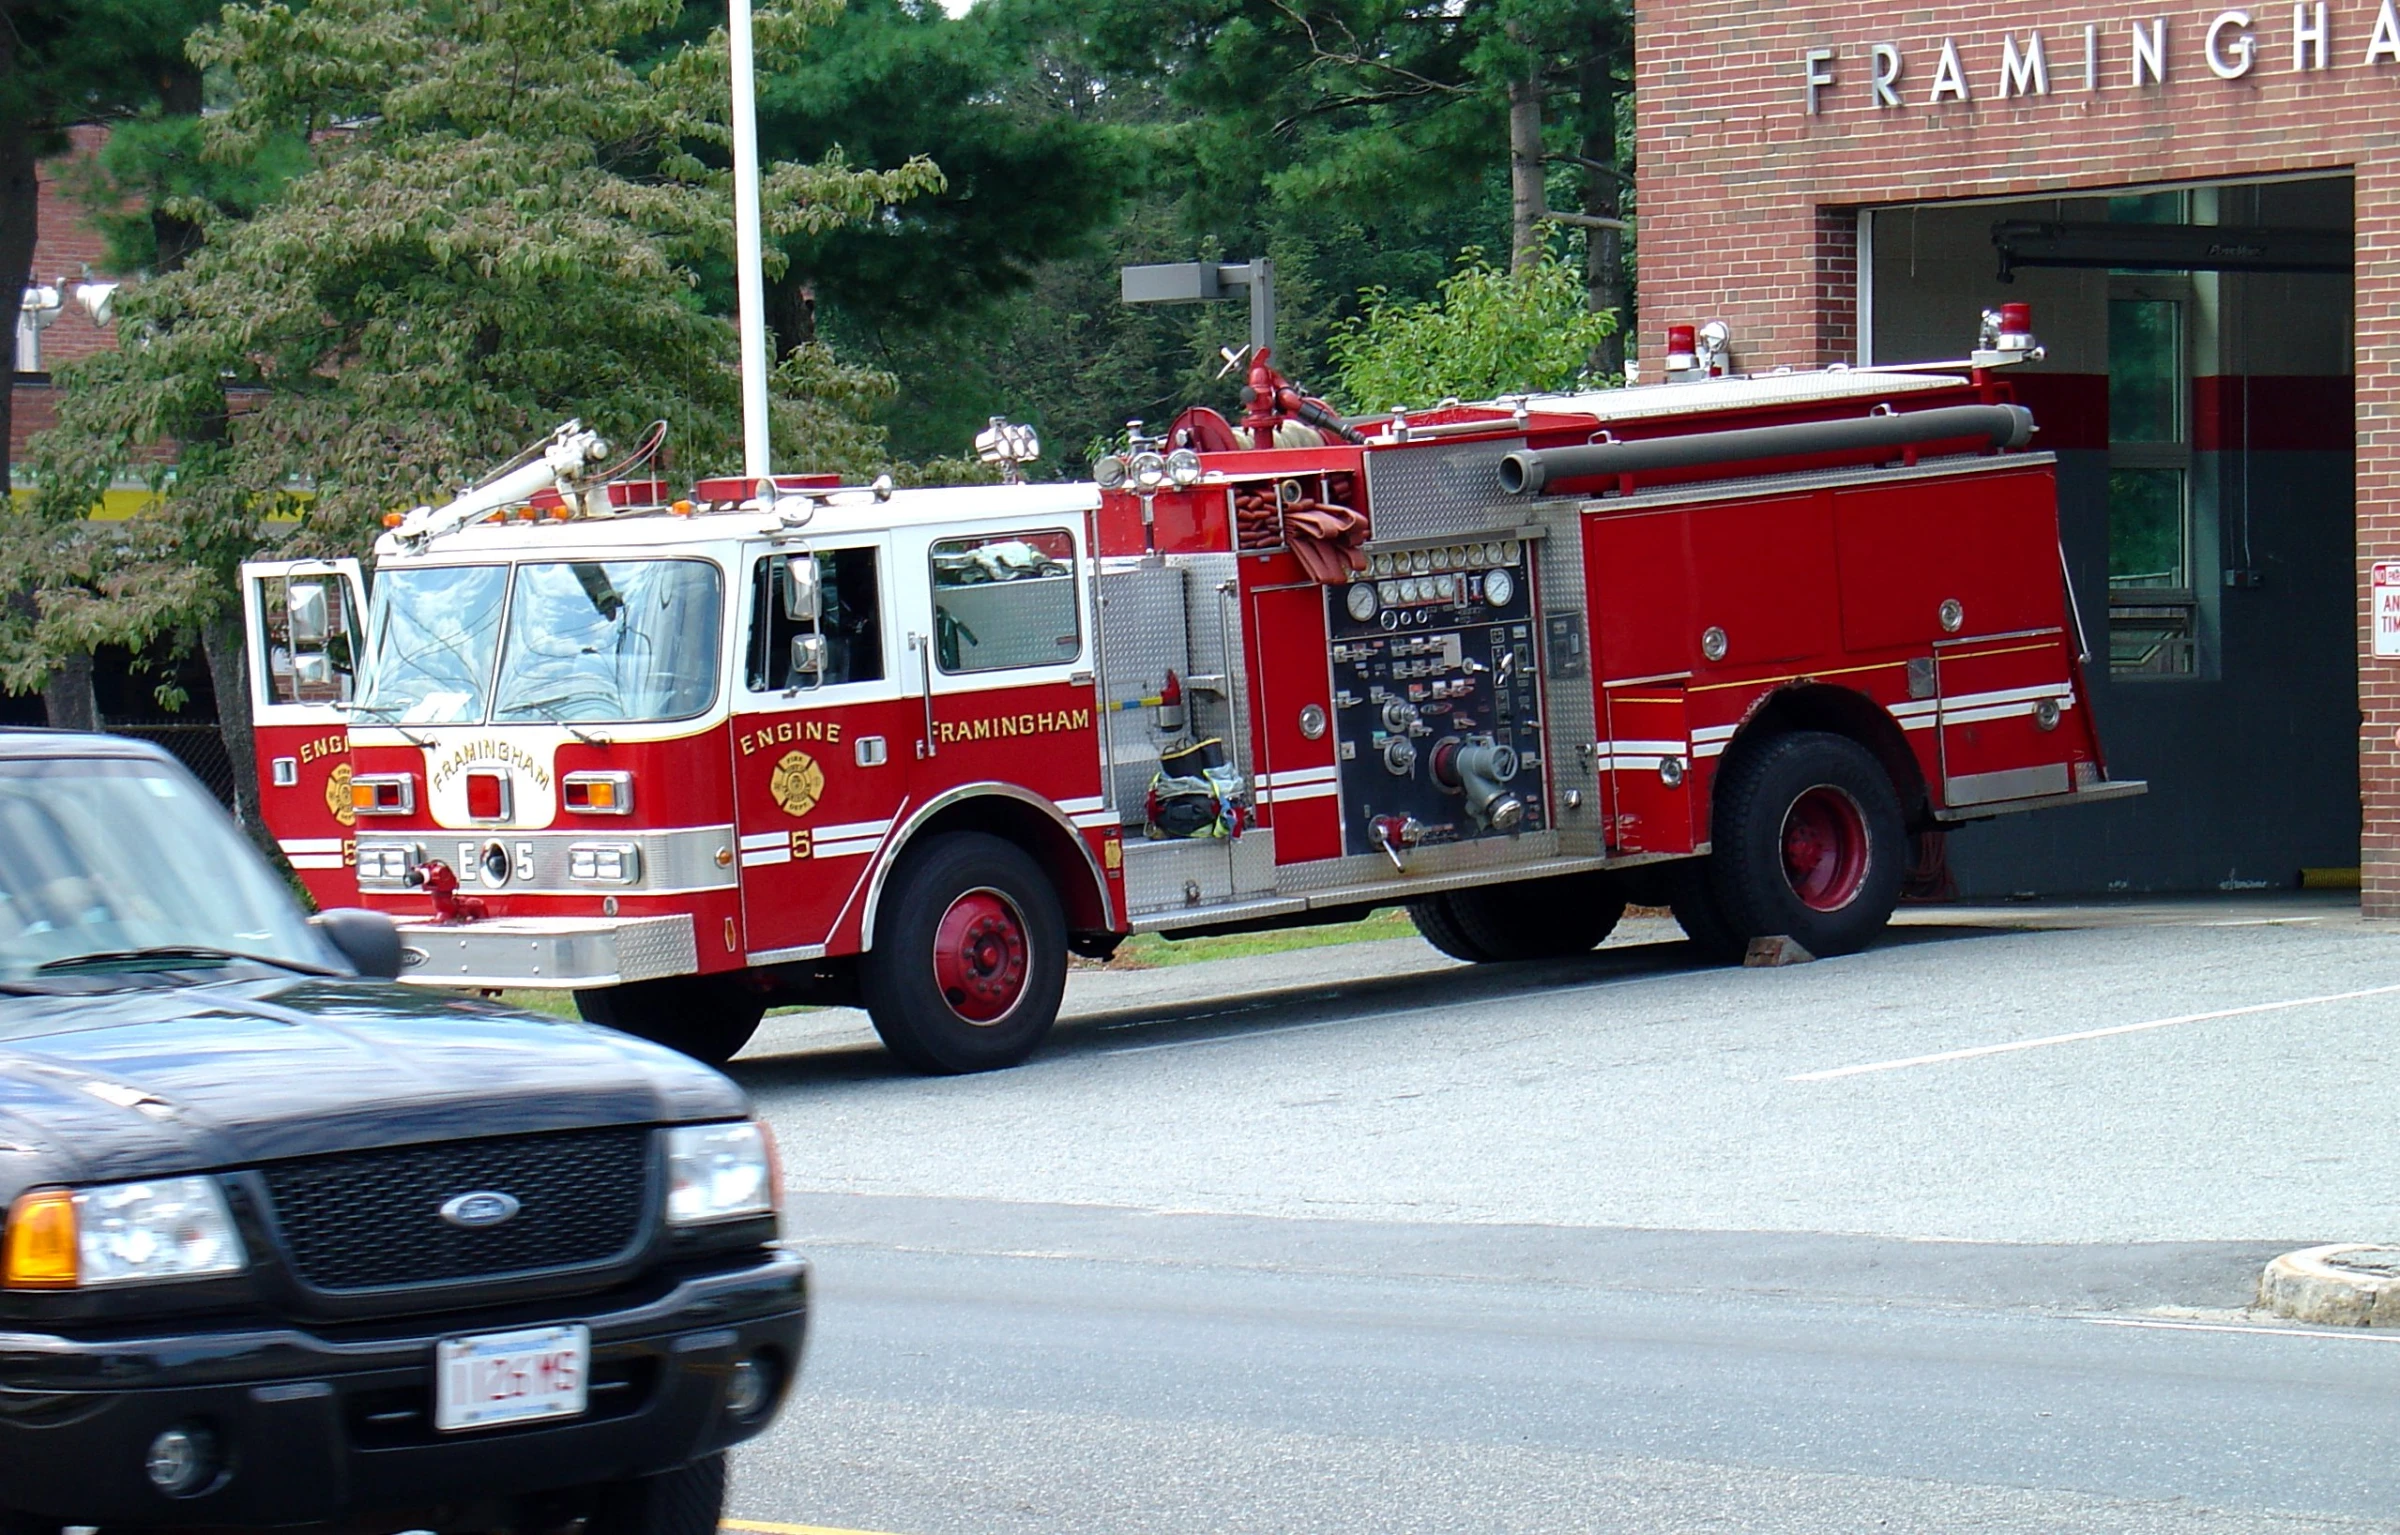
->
[[5, 1178, 250, 1290]]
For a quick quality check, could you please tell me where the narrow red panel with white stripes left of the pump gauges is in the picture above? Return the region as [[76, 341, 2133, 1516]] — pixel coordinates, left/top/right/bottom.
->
[[1250, 583, 1342, 863]]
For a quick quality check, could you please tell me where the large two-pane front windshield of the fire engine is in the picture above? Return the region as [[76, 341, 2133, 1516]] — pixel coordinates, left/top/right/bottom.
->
[[358, 559, 722, 724]]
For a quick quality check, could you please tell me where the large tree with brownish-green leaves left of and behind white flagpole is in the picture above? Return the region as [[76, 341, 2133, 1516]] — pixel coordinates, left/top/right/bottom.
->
[[0, 0, 941, 684]]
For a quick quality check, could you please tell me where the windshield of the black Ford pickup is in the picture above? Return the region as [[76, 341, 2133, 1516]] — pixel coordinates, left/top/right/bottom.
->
[[0, 758, 338, 981]]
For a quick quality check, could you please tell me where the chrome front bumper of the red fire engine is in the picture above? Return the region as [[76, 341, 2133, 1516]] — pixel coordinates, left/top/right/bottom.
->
[[401, 916, 701, 991]]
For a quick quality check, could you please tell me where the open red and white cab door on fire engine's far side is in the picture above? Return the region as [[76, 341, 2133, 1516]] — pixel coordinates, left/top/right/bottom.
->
[[242, 559, 367, 907]]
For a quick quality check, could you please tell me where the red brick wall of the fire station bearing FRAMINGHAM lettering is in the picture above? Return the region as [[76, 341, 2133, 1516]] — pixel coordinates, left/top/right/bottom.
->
[[1637, 0, 2400, 916]]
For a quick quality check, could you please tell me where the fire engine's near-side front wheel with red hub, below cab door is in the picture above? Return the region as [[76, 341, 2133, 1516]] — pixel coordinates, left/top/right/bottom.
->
[[859, 832, 1066, 1075]]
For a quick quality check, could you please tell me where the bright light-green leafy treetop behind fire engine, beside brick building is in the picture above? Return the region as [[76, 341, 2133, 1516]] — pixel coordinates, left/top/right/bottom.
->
[[1332, 249, 1618, 410]]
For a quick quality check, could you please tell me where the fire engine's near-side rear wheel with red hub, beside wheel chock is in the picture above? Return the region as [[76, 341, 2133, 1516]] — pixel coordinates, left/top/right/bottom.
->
[[1709, 732, 1908, 957]]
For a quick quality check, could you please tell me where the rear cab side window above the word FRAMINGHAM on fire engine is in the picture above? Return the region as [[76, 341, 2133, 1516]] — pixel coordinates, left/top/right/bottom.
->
[[934, 528, 1082, 674]]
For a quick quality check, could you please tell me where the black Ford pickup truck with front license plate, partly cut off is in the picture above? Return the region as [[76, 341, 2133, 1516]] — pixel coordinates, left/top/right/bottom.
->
[[0, 732, 806, 1535]]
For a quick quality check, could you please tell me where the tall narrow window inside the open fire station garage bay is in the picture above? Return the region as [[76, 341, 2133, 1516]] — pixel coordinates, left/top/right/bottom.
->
[[2107, 276, 2198, 676]]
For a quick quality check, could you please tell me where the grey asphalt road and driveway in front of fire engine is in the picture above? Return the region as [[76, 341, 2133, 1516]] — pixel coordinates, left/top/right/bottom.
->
[[734, 899, 2400, 1535]]
